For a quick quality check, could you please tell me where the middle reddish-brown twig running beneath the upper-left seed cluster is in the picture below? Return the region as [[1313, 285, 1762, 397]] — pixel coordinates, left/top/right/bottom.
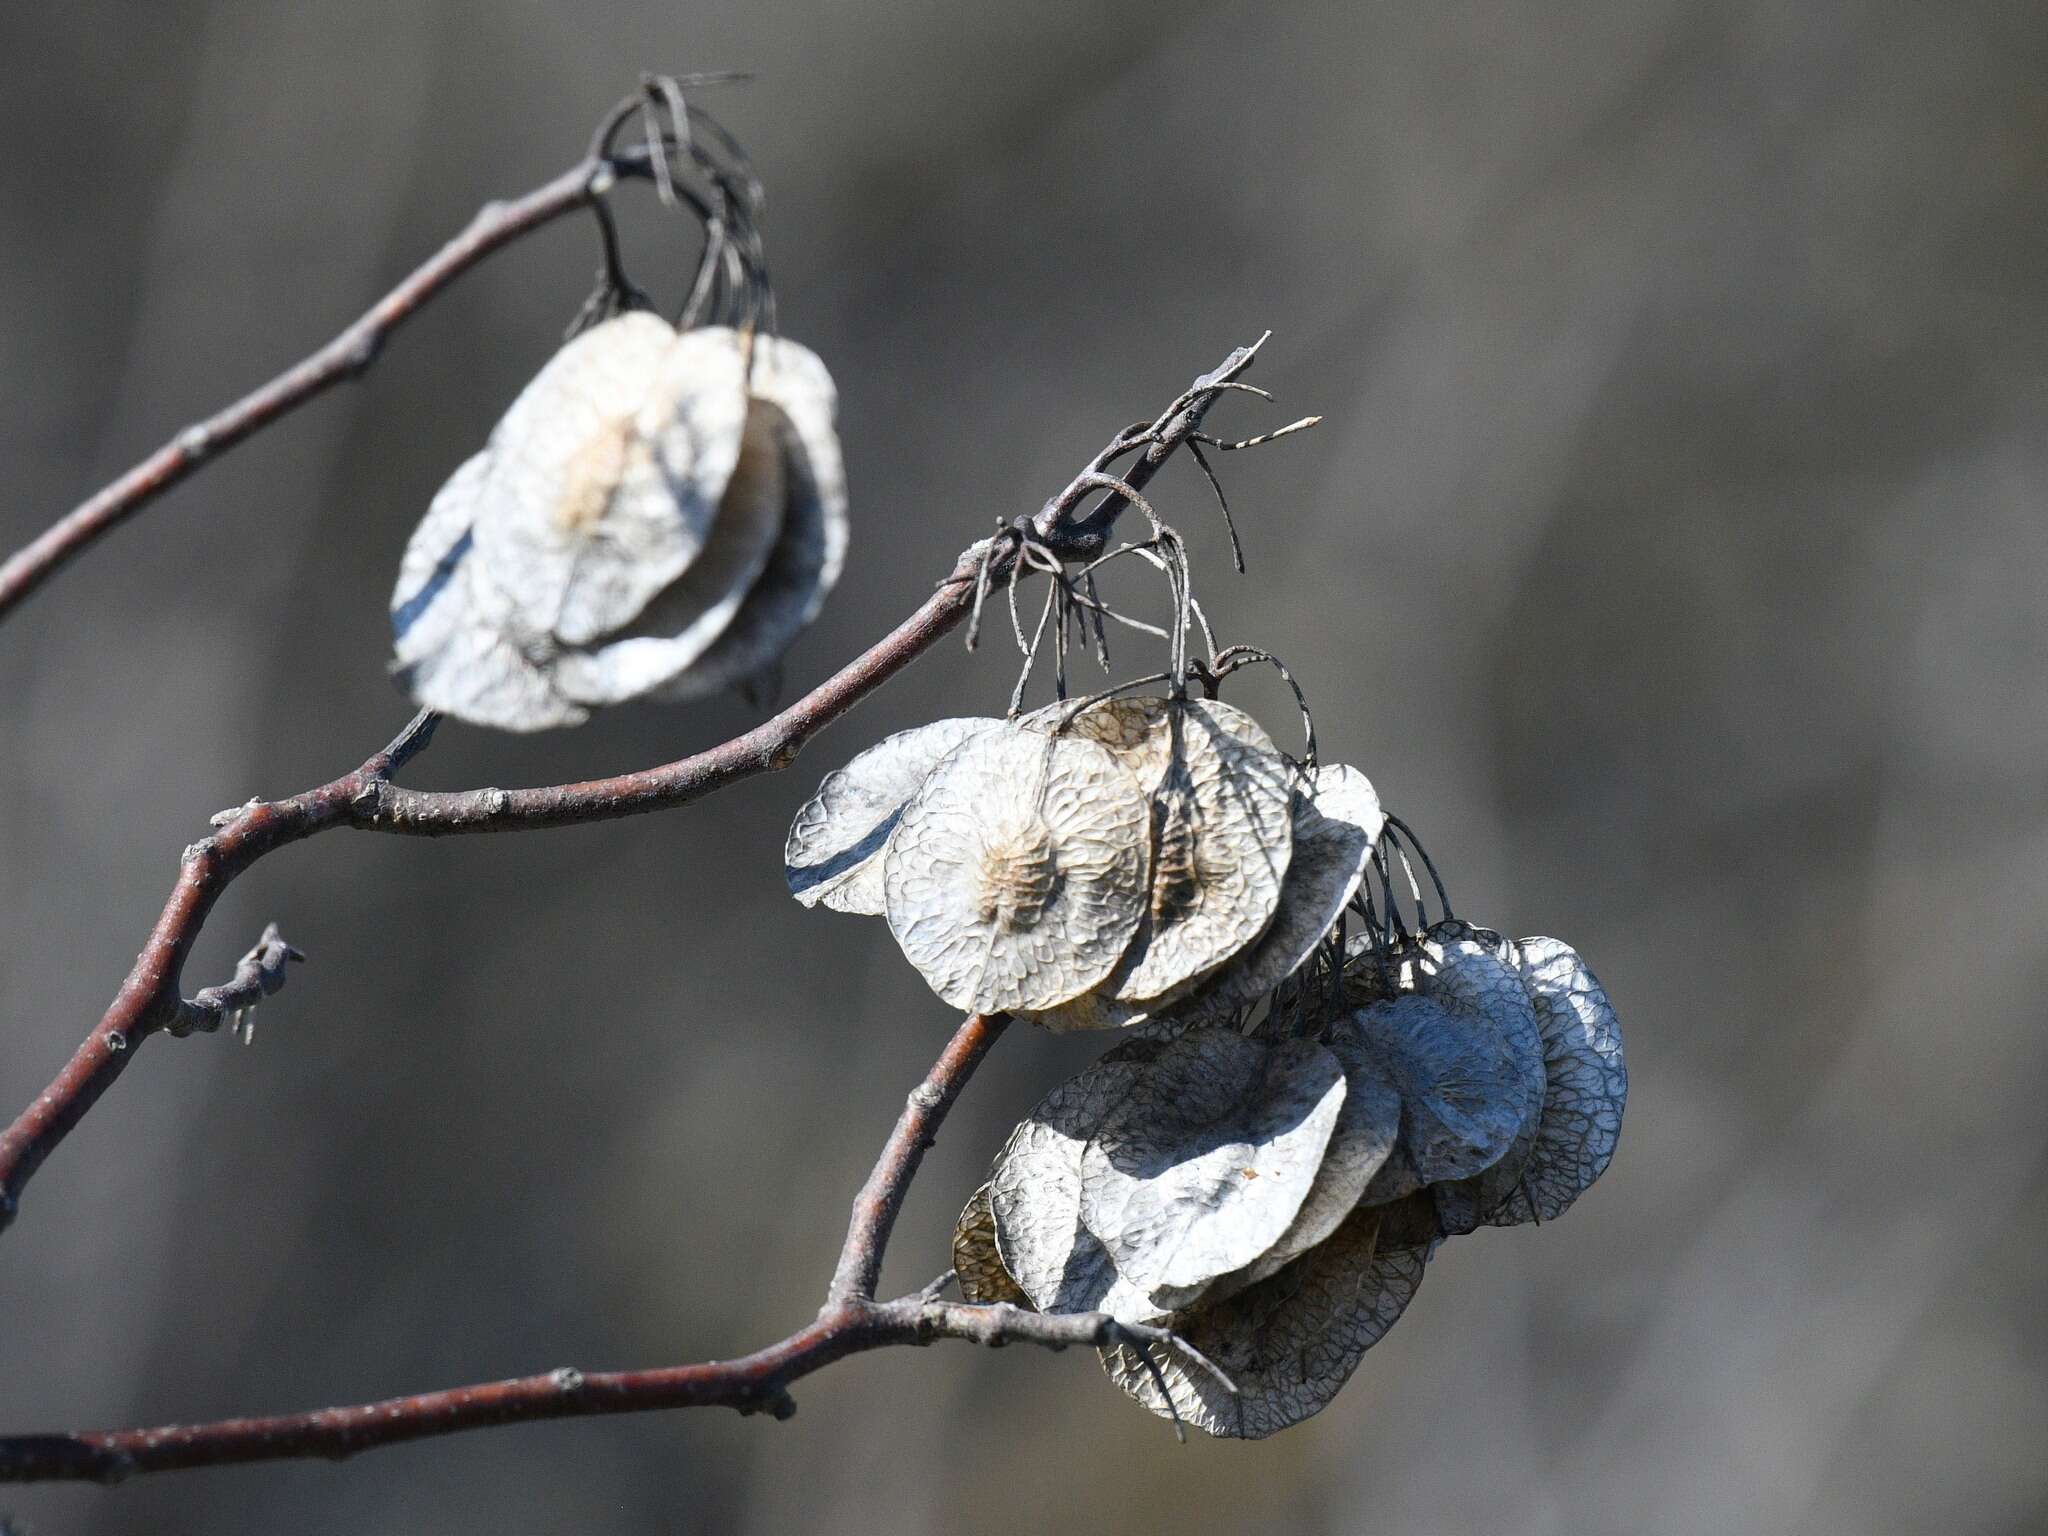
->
[[0, 348, 1251, 1231]]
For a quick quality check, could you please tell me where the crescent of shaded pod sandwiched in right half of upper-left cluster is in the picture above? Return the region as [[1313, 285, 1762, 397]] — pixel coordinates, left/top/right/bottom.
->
[[549, 399, 795, 705]]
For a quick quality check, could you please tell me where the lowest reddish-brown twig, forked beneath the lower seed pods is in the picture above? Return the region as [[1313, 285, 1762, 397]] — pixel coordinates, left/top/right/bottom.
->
[[0, 1014, 1206, 1483]]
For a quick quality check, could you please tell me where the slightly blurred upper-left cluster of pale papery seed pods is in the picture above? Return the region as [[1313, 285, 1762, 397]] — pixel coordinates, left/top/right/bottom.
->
[[391, 309, 846, 731]]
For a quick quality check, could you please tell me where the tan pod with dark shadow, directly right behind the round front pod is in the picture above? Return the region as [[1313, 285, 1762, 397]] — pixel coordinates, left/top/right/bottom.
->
[[1024, 698, 1294, 1030]]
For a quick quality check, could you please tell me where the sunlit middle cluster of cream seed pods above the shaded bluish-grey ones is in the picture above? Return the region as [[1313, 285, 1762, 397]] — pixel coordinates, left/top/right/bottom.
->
[[784, 698, 1380, 1030]]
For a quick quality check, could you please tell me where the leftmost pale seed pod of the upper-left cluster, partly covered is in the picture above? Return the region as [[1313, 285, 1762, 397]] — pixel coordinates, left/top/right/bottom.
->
[[391, 453, 590, 731]]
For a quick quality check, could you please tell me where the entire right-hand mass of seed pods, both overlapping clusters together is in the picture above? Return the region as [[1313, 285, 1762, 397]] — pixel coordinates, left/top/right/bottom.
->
[[784, 698, 1628, 1438]]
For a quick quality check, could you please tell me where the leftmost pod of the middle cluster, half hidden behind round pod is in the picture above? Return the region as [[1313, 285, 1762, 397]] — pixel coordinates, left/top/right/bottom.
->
[[782, 719, 1001, 918]]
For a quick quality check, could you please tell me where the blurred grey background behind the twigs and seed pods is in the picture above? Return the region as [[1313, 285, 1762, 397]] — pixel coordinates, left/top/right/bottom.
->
[[0, 0, 2048, 1536]]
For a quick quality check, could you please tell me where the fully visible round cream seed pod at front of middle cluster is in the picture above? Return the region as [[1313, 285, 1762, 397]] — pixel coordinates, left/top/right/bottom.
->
[[883, 727, 1151, 1012]]
